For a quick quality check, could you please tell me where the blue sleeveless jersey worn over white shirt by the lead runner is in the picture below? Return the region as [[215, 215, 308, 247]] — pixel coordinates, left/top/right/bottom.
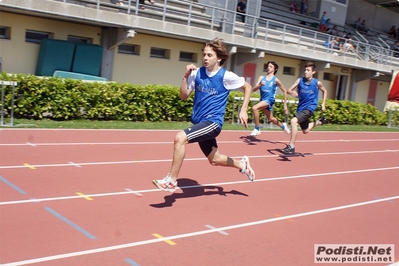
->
[[191, 67, 230, 128]]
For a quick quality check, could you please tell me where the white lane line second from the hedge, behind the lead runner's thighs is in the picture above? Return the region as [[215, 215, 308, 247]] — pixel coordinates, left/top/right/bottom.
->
[[0, 138, 399, 146]]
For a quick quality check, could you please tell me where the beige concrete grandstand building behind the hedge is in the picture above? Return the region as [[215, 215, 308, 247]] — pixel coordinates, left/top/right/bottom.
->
[[0, 0, 399, 110]]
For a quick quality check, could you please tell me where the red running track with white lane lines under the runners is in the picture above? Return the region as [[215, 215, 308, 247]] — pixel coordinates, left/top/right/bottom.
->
[[0, 129, 399, 266]]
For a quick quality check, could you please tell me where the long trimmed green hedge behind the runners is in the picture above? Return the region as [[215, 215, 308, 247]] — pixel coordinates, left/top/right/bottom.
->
[[0, 73, 399, 125]]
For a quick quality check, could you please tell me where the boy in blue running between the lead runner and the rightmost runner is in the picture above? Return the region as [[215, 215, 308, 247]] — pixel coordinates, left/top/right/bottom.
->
[[250, 61, 290, 136]]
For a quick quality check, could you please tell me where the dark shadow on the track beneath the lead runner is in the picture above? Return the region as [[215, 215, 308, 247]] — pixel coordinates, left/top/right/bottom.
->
[[150, 178, 248, 208]]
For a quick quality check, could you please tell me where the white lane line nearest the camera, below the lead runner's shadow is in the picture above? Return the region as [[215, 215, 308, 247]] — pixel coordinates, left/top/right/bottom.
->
[[2, 195, 399, 266]]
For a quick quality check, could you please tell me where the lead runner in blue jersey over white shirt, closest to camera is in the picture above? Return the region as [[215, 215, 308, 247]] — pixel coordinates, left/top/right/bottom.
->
[[153, 39, 255, 192]]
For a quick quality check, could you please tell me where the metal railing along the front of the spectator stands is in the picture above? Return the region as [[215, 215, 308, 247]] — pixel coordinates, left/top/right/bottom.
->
[[54, 0, 399, 67]]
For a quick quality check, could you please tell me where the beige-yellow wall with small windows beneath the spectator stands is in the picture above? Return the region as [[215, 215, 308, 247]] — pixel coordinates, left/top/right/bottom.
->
[[0, 9, 389, 110]]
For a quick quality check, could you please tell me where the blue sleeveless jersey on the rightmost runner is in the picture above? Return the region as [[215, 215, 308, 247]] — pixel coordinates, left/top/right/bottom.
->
[[297, 77, 319, 113]]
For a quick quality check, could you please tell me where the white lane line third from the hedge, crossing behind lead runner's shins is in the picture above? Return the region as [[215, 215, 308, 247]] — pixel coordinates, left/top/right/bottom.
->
[[0, 150, 399, 169]]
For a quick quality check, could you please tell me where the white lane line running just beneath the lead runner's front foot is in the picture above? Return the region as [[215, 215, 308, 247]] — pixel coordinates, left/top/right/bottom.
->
[[0, 166, 399, 205]]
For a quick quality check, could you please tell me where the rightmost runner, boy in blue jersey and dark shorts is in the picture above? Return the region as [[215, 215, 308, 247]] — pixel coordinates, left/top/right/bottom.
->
[[281, 62, 327, 154]]
